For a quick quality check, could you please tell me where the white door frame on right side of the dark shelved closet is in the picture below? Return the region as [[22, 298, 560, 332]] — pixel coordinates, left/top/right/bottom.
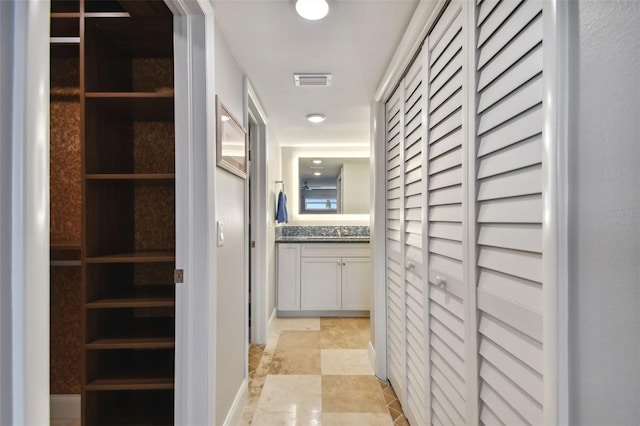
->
[[165, 0, 217, 424]]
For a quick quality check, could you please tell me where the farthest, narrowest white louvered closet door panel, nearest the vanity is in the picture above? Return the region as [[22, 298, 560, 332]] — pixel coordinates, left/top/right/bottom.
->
[[386, 87, 406, 401]]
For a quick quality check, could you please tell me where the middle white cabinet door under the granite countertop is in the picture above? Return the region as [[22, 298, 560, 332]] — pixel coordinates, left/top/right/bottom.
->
[[300, 257, 342, 311]]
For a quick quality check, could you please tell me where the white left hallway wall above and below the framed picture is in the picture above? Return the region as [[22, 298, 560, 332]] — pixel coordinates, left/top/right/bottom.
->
[[211, 22, 247, 425]]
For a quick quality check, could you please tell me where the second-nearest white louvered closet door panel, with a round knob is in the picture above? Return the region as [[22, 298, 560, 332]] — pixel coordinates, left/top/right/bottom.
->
[[426, 1, 477, 425]]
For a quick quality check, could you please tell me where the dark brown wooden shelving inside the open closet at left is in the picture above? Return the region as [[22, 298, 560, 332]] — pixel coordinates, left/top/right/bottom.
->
[[51, 0, 175, 425]]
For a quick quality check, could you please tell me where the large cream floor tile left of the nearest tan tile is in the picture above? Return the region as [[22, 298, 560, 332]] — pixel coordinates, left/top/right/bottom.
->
[[256, 375, 322, 413]]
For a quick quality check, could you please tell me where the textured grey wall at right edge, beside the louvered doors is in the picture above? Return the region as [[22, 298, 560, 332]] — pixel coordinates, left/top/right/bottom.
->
[[569, 0, 640, 426]]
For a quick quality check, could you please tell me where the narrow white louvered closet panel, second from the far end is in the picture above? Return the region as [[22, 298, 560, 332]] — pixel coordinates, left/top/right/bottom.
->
[[401, 50, 428, 425]]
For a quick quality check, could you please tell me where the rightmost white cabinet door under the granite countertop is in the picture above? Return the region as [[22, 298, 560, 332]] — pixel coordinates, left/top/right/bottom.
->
[[342, 257, 371, 311]]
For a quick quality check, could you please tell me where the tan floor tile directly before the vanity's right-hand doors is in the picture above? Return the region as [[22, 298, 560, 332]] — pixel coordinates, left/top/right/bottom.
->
[[320, 318, 371, 349]]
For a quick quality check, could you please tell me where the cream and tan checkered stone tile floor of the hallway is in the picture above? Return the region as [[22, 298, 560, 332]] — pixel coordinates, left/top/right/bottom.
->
[[240, 318, 409, 426]]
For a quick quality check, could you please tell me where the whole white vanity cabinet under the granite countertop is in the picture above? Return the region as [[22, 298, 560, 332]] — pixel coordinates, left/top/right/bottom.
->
[[277, 243, 371, 315]]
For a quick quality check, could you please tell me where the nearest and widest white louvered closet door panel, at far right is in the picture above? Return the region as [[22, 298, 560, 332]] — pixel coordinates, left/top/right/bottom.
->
[[475, 0, 543, 425]]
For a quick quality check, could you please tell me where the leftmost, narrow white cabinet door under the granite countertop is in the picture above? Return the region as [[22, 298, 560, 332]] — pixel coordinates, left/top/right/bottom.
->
[[278, 244, 300, 311]]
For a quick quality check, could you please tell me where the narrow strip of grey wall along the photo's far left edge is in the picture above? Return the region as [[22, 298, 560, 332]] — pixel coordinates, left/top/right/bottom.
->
[[0, 1, 13, 425]]
